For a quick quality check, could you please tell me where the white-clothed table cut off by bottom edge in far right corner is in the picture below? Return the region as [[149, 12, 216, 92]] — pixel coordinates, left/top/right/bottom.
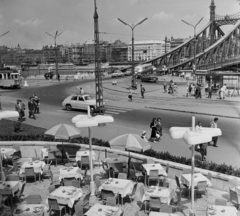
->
[[206, 205, 238, 216]]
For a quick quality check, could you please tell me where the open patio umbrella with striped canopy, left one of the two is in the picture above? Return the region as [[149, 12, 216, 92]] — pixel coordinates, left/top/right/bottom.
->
[[44, 124, 80, 162]]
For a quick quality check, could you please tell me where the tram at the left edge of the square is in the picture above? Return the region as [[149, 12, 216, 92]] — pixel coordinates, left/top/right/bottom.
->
[[0, 68, 22, 88]]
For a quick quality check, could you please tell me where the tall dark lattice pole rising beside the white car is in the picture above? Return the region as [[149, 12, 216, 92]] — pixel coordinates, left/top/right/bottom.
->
[[93, 0, 105, 115]]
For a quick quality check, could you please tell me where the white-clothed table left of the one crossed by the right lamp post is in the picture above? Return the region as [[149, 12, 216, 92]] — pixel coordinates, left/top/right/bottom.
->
[[142, 186, 175, 204]]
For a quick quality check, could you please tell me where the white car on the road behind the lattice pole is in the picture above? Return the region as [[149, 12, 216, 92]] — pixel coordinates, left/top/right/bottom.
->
[[62, 94, 105, 111]]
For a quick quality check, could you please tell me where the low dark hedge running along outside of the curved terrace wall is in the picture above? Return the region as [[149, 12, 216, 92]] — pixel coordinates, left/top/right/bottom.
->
[[0, 134, 240, 177]]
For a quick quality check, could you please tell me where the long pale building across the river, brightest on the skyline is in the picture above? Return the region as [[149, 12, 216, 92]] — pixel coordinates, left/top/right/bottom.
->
[[128, 40, 170, 62]]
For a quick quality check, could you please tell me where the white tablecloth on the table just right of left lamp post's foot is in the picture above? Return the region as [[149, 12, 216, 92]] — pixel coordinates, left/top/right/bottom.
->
[[99, 178, 134, 197]]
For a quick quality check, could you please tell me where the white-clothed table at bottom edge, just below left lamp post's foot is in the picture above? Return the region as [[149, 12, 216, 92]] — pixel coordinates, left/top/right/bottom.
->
[[84, 203, 122, 216]]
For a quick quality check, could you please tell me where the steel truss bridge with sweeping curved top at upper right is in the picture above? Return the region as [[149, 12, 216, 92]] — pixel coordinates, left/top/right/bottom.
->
[[144, 12, 240, 71]]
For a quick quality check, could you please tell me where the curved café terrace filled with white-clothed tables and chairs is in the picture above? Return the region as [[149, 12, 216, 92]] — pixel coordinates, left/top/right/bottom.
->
[[0, 141, 240, 216]]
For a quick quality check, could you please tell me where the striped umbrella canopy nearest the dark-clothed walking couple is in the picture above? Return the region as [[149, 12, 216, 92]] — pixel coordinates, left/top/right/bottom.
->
[[109, 134, 152, 152]]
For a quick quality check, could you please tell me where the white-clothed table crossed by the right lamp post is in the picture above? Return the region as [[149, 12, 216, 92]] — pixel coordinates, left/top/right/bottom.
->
[[181, 173, 212, 188]]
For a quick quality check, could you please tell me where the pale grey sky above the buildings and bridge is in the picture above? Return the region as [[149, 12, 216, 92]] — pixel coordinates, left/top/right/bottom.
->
[[0, 0, 240, 49]]
